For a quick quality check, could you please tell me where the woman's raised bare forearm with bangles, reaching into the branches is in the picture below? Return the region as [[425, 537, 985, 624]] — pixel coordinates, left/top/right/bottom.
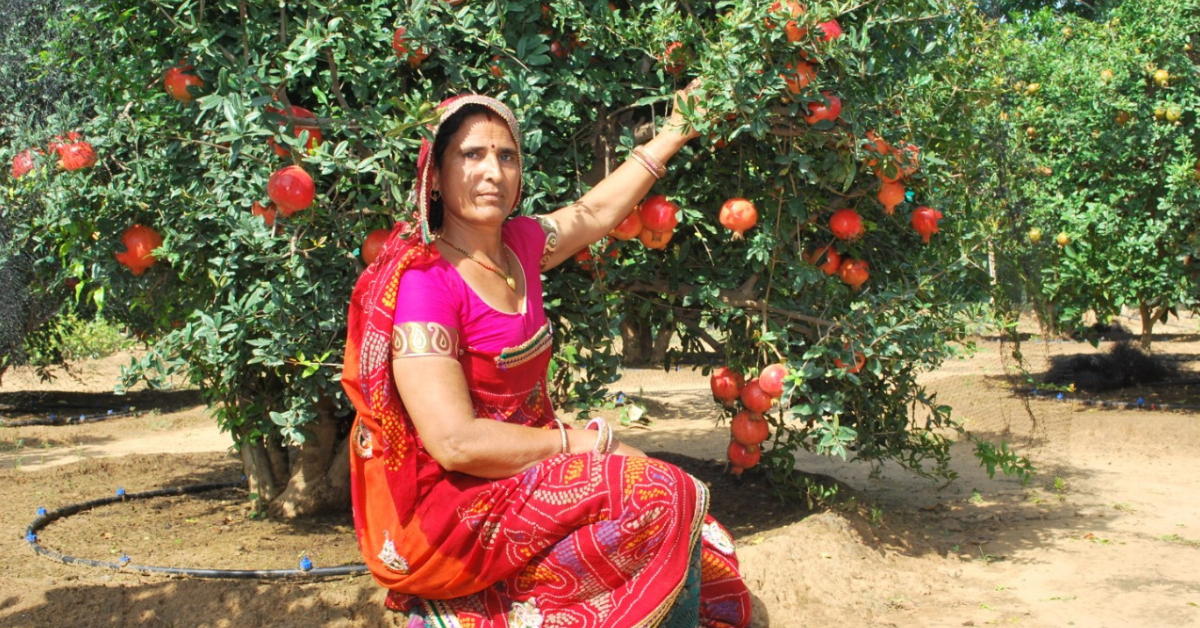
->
[[542, 85, 698, 270]]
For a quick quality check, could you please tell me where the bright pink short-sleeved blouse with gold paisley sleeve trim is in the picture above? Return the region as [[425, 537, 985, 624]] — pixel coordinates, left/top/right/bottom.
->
[[394, 216, 546, 353]]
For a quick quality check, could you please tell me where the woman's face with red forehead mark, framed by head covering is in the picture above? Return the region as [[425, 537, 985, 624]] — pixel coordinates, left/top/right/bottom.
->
[[433, 113, 521, 225]]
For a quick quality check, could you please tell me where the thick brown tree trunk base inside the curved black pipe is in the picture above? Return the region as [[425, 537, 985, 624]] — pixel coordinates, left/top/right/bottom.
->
[[232, 400, 350, 519]]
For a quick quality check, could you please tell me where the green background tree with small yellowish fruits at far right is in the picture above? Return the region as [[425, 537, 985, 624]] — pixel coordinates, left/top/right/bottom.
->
[[977, 1, 1200, 348]]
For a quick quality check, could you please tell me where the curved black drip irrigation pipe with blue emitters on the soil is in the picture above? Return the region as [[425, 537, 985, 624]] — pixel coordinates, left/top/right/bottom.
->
[[25, 482, 367, 580]]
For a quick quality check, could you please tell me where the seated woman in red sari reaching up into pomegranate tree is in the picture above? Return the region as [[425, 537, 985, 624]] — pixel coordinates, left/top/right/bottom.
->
[[343, 89, 750, 628]]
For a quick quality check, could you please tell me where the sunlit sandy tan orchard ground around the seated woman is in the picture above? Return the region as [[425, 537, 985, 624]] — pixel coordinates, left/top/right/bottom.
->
[[0, 318, 1200, 628]]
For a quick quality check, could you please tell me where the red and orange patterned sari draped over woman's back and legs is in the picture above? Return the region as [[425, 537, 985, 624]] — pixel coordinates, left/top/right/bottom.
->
[[342, 227, 750, 628]]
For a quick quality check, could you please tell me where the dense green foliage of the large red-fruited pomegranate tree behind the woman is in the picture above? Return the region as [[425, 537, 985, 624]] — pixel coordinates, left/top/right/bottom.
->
[[0, 0, 1032, 512]]
